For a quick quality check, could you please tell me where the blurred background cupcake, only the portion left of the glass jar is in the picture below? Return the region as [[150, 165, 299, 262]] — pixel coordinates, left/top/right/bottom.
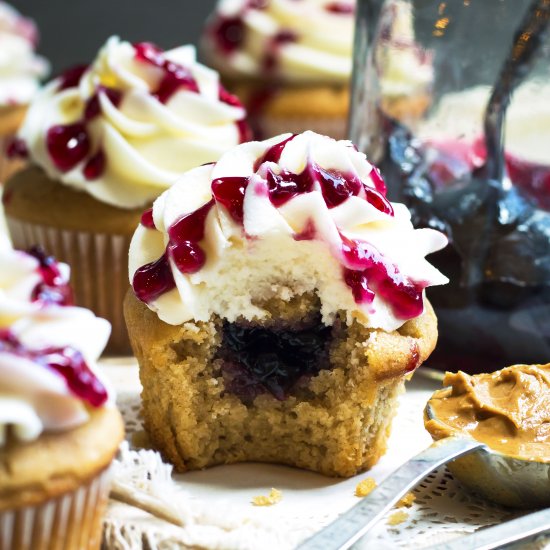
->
[[201, 0, 355, 139]]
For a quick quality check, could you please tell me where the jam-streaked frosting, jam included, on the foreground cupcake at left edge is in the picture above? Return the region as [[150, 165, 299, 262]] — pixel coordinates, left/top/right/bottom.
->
[[0, 250, 110, 446]]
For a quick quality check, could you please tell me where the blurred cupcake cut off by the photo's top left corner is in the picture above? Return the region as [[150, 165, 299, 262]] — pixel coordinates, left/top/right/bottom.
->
[[0, 2, 49, 183]]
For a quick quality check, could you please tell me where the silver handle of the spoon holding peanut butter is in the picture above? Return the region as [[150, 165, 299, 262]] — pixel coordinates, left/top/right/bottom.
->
[[298, 437, 483, 550]]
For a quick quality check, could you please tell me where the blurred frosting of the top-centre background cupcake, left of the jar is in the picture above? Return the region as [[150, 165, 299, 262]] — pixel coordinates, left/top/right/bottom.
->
[[203, 0, 355, 84]]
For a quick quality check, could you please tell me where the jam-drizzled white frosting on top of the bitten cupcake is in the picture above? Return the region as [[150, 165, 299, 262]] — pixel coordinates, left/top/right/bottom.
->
[[129, 132, 447, 331]]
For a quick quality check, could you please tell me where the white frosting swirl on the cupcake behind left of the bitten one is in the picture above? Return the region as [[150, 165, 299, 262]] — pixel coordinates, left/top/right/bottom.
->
[[20, 37, 245, 208]]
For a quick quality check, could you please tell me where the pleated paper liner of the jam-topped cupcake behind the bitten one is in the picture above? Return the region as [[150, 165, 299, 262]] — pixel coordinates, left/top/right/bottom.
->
[[6, 216, 131, 356]]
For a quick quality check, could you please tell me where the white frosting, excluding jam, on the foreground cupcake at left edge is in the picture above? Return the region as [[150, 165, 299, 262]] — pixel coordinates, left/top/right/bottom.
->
[[0, 250, 112, 446]]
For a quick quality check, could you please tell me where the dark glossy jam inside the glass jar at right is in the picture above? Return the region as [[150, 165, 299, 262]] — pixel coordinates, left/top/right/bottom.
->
[[379, 118, 550, 373]]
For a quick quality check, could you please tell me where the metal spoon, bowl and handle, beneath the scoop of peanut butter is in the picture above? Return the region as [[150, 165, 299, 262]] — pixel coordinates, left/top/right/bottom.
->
[[298, 406, 550, 550]]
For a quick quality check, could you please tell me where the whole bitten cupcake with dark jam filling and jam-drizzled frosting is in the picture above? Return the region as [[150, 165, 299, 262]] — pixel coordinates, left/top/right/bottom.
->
[[125, 132, 446, 476]]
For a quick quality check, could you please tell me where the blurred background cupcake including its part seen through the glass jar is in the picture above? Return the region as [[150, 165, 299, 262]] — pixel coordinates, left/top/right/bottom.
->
[[201, 0, 433, 139]]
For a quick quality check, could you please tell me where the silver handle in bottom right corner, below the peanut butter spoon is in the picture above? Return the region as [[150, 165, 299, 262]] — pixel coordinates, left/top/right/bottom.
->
[[429, 508, 550, 550]]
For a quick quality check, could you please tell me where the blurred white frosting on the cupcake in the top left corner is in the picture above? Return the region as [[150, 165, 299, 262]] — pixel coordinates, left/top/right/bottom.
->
[[0, 2, 49, 106]]
